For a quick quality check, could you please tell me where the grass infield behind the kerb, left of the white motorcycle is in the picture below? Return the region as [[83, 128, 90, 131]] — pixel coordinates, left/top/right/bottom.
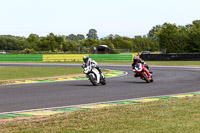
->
[[0, 67, 82, 81]]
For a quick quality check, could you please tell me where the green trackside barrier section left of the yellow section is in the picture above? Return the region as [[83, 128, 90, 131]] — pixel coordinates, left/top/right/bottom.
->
[[0, 55, 42, 62]]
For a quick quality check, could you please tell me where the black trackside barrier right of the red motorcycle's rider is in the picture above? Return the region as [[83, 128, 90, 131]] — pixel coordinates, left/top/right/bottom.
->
[[140, 54, 200, 61]]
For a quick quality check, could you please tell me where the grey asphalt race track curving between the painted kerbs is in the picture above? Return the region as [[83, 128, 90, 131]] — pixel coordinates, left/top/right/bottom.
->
[[0, 63, 200, 113]]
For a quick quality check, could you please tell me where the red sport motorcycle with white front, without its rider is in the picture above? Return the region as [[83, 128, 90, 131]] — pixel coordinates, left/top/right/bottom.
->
[[135, 63, 153, 83]]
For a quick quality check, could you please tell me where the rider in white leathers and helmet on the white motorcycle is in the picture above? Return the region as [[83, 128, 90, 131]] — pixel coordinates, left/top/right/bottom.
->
[[82, 55, 102, 74]]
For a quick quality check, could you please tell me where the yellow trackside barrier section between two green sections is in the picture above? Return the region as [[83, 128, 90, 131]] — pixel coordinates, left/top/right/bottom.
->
[[43, 54, 87, 62]]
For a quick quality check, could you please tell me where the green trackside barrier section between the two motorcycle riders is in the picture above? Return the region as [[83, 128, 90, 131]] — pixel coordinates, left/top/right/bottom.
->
[[89, 54, 132, 61]]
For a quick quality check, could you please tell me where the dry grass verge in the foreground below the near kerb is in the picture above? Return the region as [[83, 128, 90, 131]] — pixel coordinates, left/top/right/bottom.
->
[[0, 96, 200, 133]]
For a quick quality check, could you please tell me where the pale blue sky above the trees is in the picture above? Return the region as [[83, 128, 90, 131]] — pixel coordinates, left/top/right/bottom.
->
[[0, 0, 200, 37]]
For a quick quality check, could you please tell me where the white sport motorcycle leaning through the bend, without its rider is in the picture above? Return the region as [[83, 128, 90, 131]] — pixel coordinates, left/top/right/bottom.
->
[[82, 66, 106, 86]]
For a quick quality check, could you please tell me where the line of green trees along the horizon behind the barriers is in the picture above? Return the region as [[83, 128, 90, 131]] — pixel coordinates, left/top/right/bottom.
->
[[0, 20, 200, 53]]
